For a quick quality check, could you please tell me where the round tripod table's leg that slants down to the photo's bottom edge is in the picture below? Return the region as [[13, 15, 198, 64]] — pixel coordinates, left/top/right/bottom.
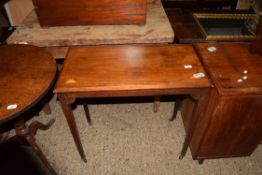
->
[[14, 120, 56, 175]]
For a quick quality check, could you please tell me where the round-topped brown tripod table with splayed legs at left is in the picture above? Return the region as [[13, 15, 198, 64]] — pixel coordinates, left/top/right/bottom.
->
[[0, 45, 56, 174]]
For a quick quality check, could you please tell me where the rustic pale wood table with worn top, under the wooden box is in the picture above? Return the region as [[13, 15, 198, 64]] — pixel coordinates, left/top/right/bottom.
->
[[7, 0, 174, 58]]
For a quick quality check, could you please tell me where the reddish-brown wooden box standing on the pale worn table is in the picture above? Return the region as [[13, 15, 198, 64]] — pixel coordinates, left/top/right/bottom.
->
[[33, 0, 147, 26]]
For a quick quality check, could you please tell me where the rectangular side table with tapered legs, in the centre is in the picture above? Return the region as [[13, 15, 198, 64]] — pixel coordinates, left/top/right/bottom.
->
[[54, 45, 211, 161]]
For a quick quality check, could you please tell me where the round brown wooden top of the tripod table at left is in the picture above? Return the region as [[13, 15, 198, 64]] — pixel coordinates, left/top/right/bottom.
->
[[0, 45, 57, 123]]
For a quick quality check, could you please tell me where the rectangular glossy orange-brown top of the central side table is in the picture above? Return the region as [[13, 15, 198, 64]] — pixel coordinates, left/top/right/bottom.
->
[[54, 45, 211, 94]]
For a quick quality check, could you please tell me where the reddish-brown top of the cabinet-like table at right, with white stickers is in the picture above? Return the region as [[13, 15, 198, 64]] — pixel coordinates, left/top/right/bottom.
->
[[196, 43, 262, 94]]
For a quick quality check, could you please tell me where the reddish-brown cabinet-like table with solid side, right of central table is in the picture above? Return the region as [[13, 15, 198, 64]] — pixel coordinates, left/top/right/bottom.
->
[[182, 43, 262, 160]]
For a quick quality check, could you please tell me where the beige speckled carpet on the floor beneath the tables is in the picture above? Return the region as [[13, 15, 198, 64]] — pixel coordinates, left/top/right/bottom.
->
[[33, 97, 262, 175]]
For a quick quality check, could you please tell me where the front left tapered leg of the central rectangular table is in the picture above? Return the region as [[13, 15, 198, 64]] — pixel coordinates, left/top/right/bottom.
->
[[59, 97, 87, 162]]
